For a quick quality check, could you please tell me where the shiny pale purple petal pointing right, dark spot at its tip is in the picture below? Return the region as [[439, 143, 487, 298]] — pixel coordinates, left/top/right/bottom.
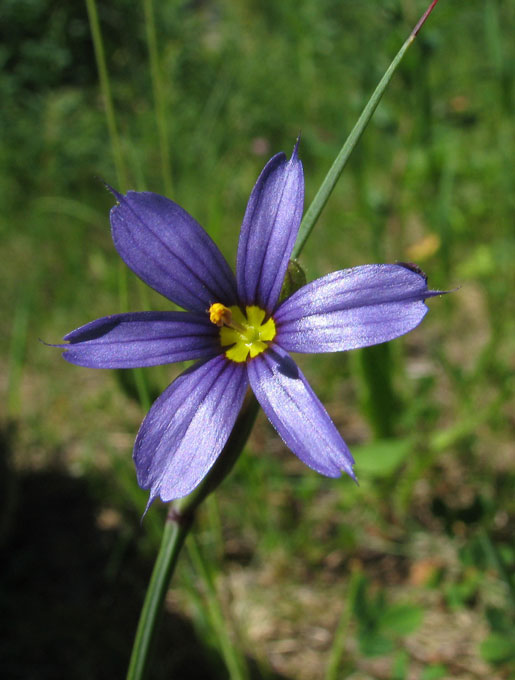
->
[[274, 264, 441, 352]]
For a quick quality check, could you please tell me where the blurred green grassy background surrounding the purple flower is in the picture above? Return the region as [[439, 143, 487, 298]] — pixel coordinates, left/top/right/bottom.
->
[[0, 0, 515, 680]]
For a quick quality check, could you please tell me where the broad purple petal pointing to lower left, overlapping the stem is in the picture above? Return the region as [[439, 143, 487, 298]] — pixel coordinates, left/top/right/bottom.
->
[[134, 356, 247, 505]]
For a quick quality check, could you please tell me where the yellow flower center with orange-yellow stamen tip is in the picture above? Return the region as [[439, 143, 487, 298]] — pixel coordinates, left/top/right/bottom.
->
[[209, 302, 276, 363]]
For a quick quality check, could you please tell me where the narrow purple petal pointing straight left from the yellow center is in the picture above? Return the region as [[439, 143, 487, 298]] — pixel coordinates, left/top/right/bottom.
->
[[58, 312, 220, 368]]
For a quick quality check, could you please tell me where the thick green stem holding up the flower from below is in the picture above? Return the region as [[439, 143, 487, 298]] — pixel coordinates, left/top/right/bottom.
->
[[127, 394, 259, 680]]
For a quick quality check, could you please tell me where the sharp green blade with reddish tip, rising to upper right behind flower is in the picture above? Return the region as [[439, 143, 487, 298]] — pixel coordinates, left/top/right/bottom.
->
[[292, 0, 438, 258]]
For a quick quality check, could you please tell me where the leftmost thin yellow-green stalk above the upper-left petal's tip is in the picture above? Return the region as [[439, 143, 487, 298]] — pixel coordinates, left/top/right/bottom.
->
[[143, 0, 172, 196]]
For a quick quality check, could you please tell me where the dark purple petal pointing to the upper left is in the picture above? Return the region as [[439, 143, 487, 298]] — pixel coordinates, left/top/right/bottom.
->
[[111, 191, 236, 312]]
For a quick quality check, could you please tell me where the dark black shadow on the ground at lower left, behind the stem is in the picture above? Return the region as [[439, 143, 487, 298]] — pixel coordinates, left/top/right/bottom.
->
[[0, 428, 288, 680]]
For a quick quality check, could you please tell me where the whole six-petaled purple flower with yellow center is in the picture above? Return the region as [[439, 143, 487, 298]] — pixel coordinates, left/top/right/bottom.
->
[[61, 143, 438, 504]]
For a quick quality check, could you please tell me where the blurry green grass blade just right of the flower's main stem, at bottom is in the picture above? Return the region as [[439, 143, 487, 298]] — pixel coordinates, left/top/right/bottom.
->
[[186, 535, 250, 680]]
